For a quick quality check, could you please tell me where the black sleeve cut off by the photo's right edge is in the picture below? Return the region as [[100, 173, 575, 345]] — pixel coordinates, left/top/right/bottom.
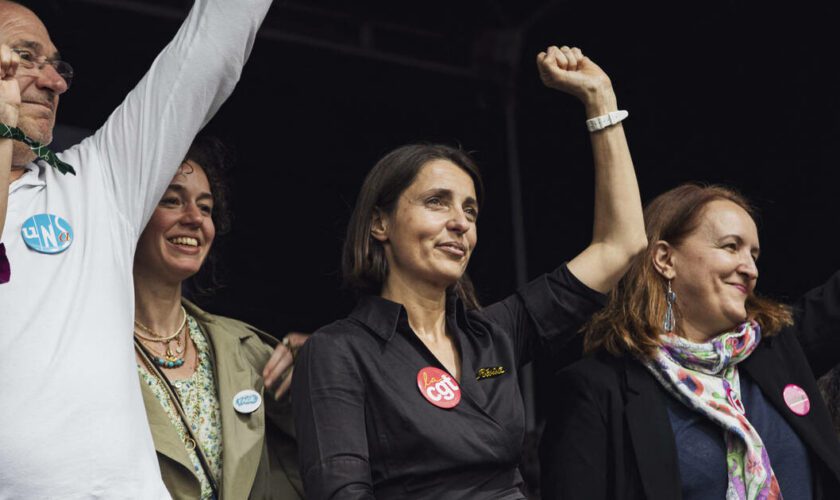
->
[[791, 272, 840, 378]]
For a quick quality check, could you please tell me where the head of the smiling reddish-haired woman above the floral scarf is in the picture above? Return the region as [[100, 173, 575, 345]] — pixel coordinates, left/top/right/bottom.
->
[[586, 184, 791, 357]]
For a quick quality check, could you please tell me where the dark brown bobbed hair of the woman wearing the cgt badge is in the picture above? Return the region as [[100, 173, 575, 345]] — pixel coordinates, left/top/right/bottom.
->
[[341, 144, 484, 309]]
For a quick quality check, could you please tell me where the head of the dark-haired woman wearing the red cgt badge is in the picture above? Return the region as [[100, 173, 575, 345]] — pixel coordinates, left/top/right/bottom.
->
[[342, 144, 484, 308]]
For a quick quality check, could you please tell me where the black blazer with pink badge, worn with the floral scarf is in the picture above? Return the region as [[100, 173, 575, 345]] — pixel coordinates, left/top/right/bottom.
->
[[540, 273, 840, 500]]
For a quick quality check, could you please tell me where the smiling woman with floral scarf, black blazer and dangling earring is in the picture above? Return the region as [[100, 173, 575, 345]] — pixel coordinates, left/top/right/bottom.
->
[[541, 184, 840, 500]]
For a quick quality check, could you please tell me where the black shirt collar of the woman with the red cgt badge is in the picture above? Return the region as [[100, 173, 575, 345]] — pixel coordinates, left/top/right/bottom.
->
[[350, 291, 466, 342]]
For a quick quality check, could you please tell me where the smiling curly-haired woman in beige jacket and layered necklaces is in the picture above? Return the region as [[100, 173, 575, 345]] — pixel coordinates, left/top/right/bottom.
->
[[134, 139, 303, 499]]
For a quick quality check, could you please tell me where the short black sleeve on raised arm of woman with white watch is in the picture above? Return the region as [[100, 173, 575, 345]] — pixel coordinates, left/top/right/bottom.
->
[[482, 264, 607, 366]]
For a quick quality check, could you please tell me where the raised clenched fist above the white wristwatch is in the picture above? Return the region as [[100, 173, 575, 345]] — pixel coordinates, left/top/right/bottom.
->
[[537, 45, 615, 114]]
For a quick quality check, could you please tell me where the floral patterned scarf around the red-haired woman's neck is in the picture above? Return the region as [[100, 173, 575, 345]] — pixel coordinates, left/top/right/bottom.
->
[[645, 321, 782, 500]]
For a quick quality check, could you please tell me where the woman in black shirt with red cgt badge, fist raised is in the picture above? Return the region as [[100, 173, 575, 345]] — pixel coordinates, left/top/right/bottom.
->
[[292, 47, 646, 499]]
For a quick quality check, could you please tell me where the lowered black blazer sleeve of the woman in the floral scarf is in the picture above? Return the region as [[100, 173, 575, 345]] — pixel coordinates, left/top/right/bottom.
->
[[540, 370, 609, 500]]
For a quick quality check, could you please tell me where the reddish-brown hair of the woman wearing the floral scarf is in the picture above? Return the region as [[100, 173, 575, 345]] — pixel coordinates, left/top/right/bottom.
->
[[584, 184, 793, 359]]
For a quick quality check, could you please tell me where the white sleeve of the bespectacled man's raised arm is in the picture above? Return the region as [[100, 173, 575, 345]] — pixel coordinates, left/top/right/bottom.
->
[[79, 0, 271, 236]]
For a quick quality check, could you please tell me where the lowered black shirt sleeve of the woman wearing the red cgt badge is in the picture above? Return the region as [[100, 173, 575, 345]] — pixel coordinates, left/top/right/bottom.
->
[[292, 332, 373, 500]]
